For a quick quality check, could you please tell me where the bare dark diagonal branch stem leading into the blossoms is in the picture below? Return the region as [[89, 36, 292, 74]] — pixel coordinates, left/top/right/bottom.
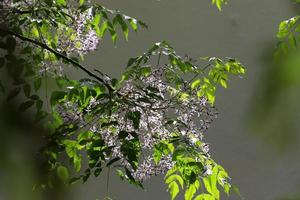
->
[[0, 28, 114, 92]]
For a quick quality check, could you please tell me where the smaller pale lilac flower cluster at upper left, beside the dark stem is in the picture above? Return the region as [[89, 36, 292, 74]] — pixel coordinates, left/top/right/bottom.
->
[[0, 0, 100, 76]]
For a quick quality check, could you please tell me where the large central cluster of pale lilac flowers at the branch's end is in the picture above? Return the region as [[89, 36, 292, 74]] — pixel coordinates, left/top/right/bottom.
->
[[55, 64, 216, 181]]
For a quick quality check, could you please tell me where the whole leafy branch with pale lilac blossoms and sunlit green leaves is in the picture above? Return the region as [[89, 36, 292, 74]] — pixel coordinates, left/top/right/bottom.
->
[[0, 0, 245, 200]]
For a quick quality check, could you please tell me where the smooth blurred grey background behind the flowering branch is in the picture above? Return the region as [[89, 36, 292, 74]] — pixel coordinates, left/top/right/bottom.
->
[[0, 0, 300, 200]]
